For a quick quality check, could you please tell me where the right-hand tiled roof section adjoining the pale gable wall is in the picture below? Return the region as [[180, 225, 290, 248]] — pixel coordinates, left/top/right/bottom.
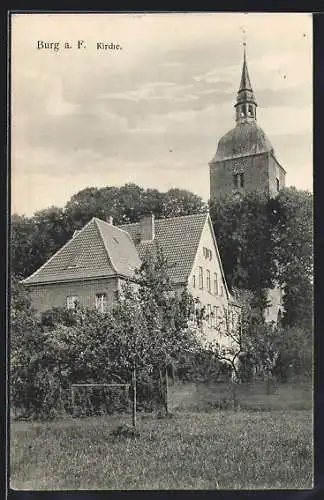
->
[[119, 213, 207, 283]]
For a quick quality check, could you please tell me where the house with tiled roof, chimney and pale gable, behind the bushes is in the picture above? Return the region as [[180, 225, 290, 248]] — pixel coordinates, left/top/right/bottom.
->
[[23, 213, 239, 348]]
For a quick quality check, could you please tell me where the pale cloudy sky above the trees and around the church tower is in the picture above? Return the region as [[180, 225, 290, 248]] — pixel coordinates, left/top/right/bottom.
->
[[11, 13, 313, 215]]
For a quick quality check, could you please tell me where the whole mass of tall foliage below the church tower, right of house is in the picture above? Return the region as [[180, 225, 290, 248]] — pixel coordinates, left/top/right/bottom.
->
[[210, 187, 313, 328]]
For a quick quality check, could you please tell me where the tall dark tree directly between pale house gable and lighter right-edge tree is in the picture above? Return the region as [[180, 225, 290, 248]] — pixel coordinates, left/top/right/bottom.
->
[[210, 193, 276, 307]]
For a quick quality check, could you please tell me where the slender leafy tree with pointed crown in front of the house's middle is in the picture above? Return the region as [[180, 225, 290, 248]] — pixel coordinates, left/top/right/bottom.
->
[[114, 245, 196, 413]]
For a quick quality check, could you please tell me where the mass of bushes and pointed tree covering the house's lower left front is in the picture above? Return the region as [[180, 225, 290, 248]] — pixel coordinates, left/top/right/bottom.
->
[[11, 251, 200, 419]]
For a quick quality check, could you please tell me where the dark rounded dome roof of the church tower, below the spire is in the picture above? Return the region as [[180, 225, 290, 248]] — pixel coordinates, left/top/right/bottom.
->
[[213, 121, 273, 161]]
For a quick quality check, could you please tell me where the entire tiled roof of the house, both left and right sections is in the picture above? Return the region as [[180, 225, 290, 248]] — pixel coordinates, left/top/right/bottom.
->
[[24, 213, 218, 290]]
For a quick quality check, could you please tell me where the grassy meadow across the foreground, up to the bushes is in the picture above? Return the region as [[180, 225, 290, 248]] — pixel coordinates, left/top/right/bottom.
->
[[10, 384, 313, 490]]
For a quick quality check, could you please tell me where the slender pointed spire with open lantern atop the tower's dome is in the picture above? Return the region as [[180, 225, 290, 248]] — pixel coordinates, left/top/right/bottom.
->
[[235, 42, 258, 123]]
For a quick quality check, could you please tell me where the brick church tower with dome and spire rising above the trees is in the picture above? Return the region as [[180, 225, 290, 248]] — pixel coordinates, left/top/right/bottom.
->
[[209, 44, 286, 200]]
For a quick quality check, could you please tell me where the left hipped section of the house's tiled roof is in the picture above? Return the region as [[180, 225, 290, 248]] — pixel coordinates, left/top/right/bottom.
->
[[24, 218, 140, 284]]
